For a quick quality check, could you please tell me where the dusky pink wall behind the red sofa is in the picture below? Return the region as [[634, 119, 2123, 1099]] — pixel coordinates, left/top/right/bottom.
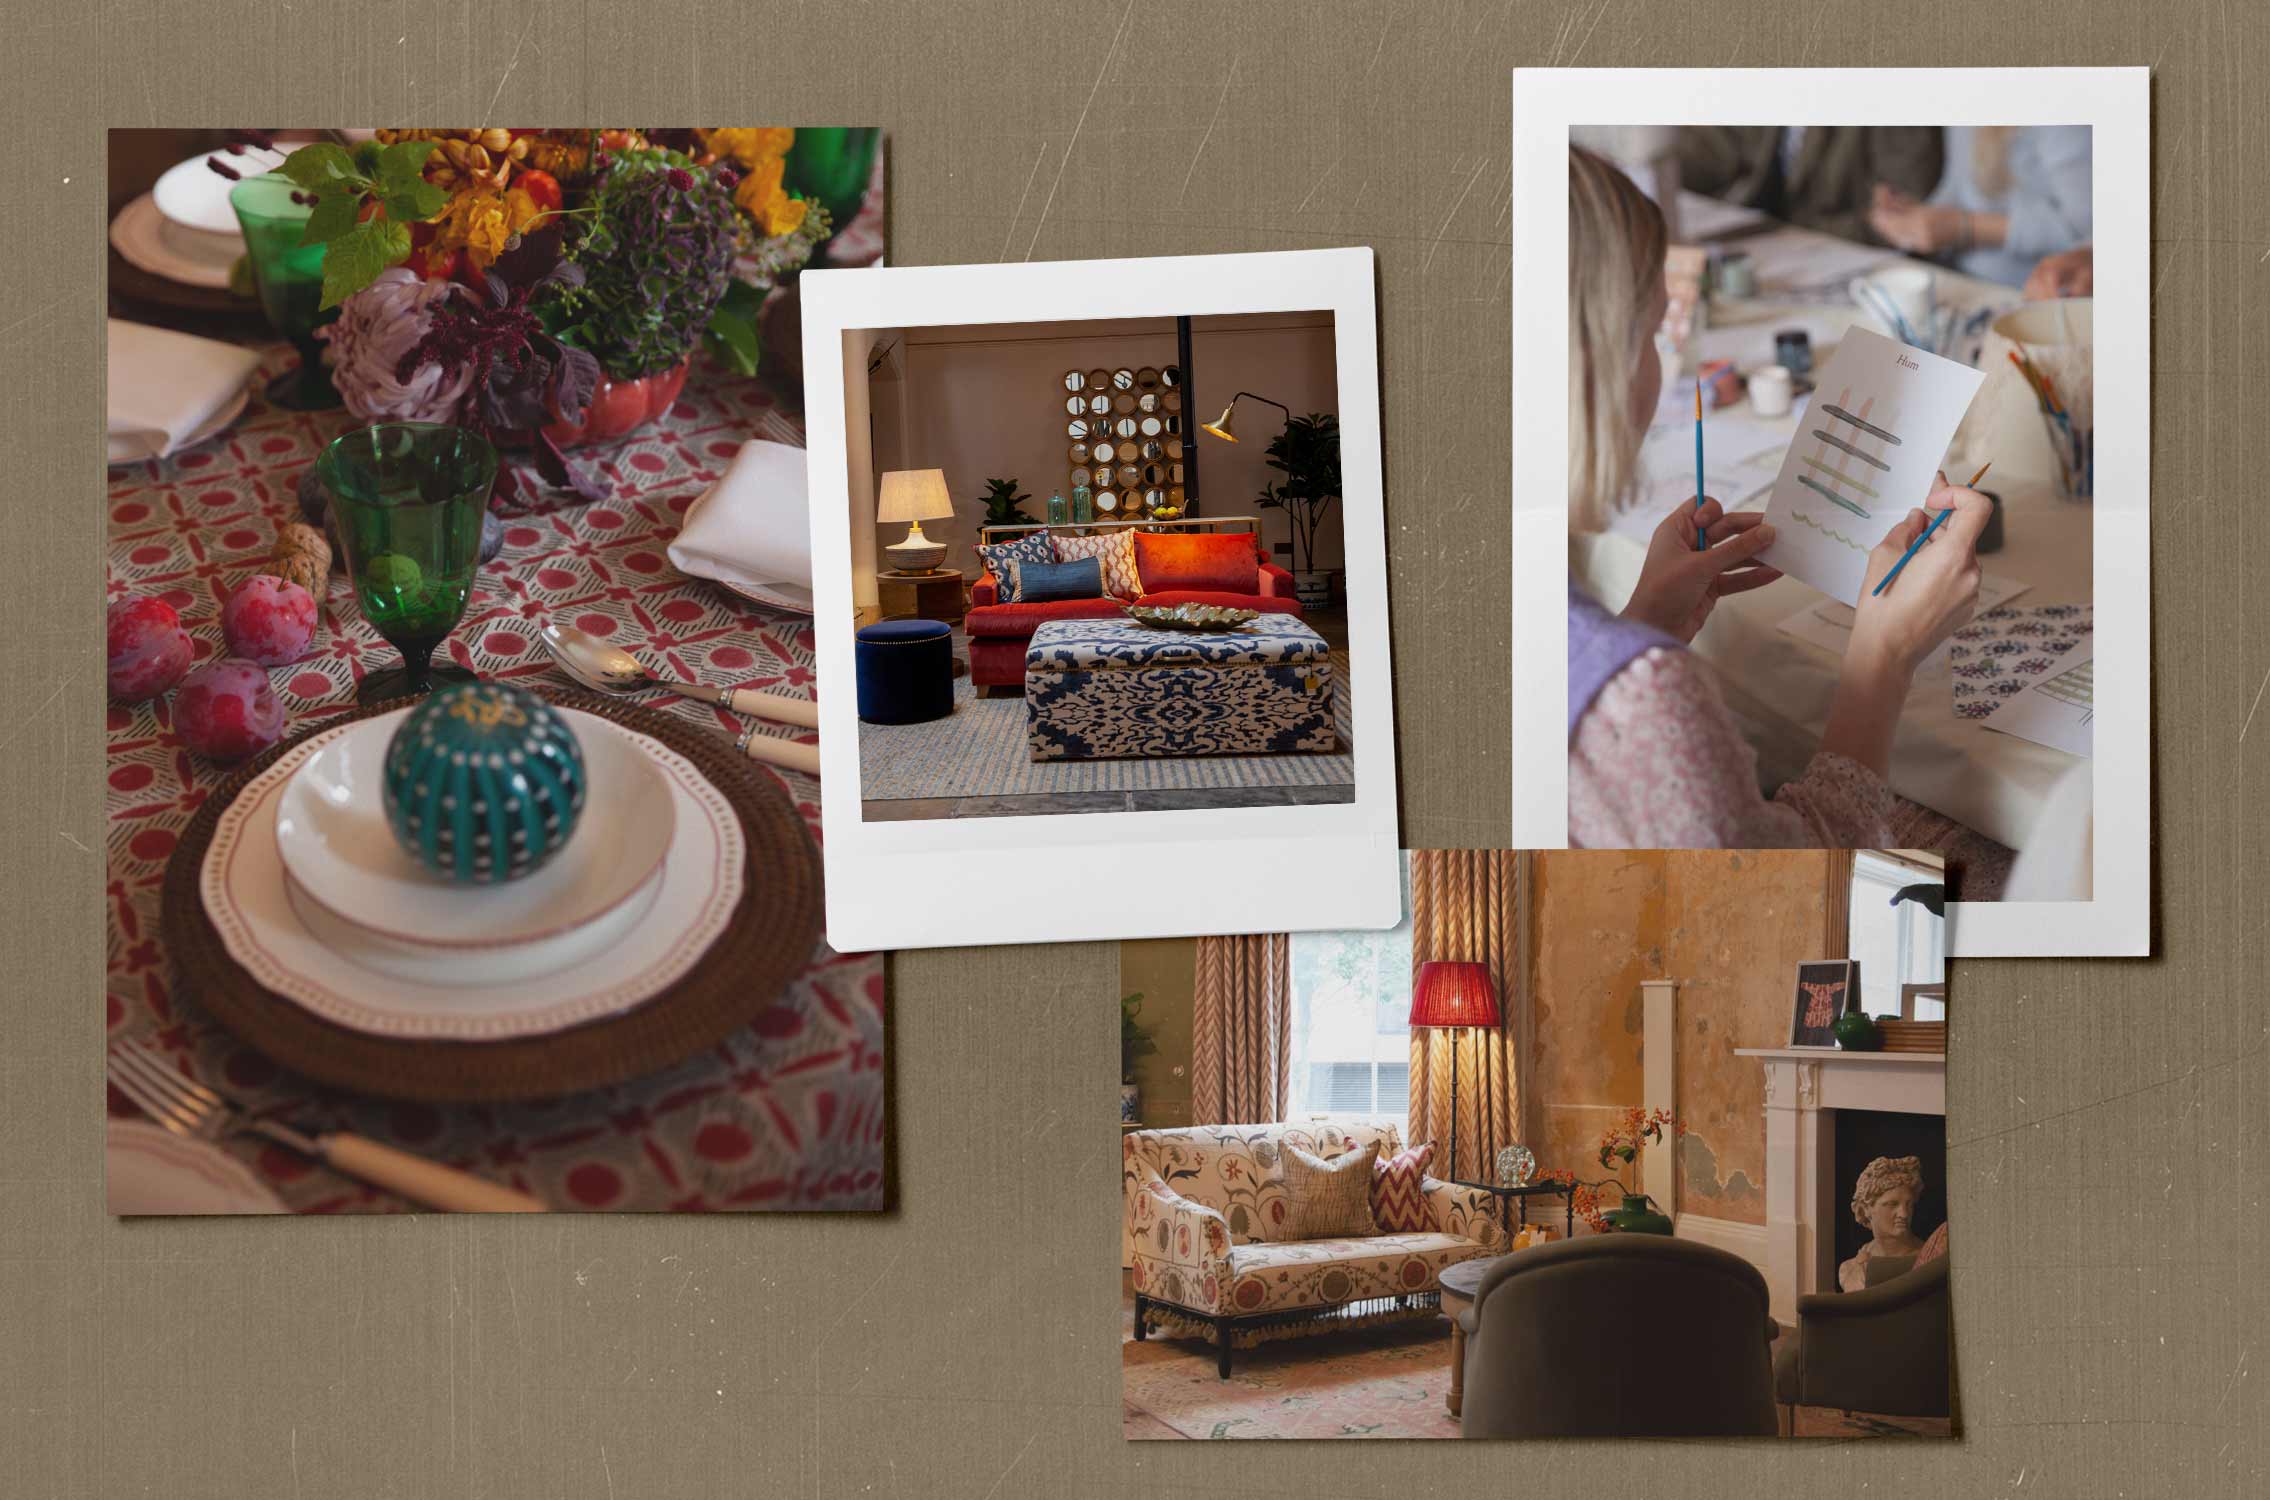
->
[[854, 313, 1342, 590]]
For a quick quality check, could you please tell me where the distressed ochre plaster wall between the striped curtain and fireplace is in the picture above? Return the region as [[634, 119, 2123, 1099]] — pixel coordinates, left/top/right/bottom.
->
[[1528, 849, 1827, 1223]]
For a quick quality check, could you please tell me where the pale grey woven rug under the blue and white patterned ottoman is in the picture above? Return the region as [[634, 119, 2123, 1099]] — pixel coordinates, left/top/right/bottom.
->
[[858, 635, 1355, 801]]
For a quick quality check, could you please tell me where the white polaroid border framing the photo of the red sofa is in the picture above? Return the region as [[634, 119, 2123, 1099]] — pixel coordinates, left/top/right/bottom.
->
[[799, 250, 1403, 951]]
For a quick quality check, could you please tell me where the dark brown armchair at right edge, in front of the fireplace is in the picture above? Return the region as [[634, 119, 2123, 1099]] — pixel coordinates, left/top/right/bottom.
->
[[1773, 1255, 1952, 1432]]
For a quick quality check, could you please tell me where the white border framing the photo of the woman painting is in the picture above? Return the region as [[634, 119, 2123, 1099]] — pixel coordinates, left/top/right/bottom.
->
[[1512, 68, 2152, 958]]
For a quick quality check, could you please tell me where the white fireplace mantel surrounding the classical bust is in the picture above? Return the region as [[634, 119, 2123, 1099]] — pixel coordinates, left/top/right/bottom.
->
[[1734, 1046, 1948, 1323]]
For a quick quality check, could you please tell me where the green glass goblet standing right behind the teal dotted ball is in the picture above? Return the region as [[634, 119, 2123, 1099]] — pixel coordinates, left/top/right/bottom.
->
[[316, 422, 497, 703]]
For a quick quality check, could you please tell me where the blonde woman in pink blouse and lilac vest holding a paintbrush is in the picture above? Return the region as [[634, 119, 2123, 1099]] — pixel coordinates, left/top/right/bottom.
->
[[1569, 150, 1991, 849]]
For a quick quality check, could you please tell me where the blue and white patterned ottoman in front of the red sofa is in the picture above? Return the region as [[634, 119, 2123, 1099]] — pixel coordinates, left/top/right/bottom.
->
[[1024, 615, 1339, 760]]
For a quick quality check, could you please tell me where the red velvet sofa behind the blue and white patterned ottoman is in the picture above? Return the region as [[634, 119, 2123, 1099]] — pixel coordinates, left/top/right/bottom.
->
[[962, 531, 1301, 690]]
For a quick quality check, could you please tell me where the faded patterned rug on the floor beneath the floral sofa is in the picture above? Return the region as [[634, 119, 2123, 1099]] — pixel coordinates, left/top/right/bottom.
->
[[1119, 1312, 1950, 1441]]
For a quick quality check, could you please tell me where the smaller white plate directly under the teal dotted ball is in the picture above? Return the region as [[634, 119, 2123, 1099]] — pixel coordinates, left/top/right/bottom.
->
[[275, 708, 676, 949]]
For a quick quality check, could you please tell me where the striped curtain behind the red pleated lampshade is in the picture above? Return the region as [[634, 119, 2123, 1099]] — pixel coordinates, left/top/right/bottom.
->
[[1410, 849, 1530, 1182]]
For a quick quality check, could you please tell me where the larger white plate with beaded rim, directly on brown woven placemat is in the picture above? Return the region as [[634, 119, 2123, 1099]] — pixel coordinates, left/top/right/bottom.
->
[[200, 710, 747, 1042]]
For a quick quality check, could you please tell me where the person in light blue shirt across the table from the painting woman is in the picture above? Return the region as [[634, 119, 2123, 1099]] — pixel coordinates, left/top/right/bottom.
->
[[1868, 125, 2093, 295]]
